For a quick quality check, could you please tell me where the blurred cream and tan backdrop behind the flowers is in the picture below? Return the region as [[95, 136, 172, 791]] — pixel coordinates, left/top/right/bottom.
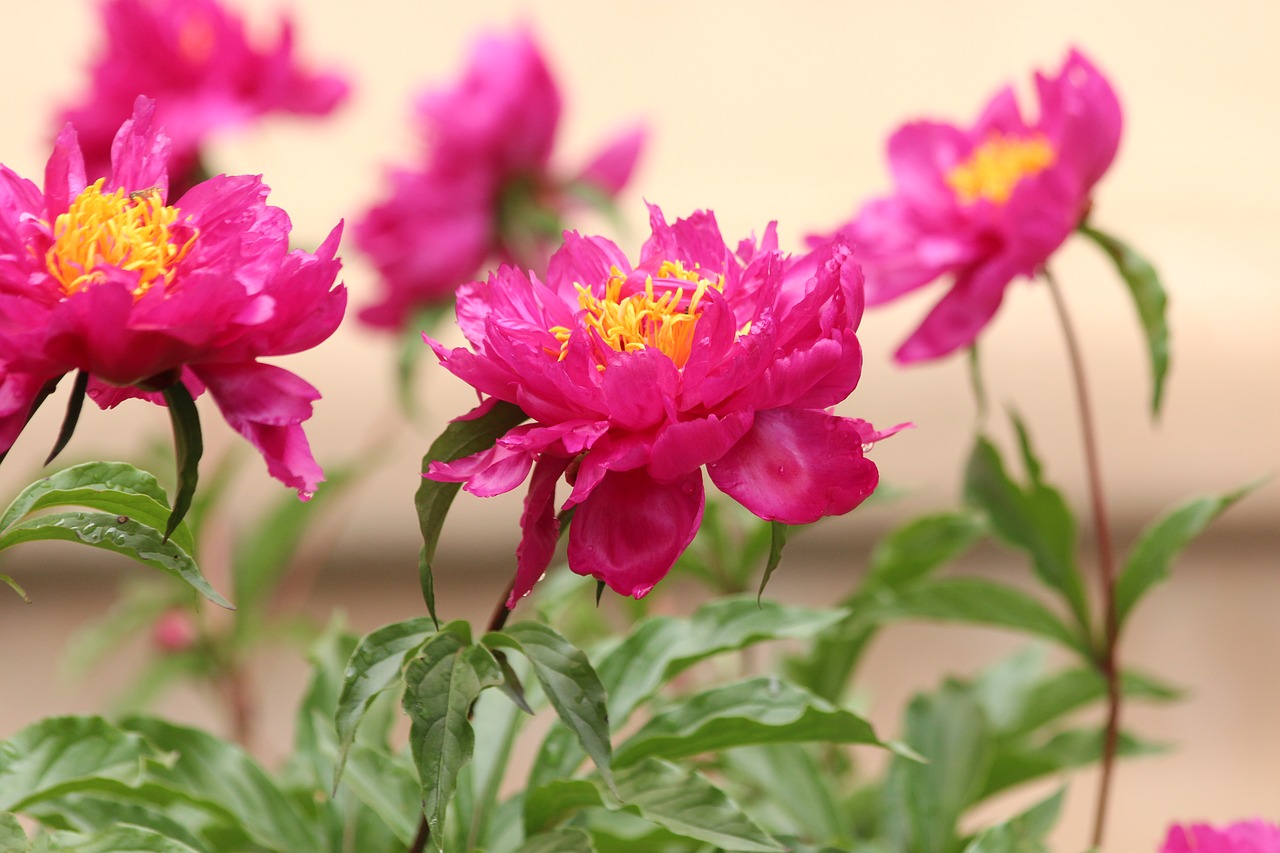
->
[[0, 0, 1280, 850]]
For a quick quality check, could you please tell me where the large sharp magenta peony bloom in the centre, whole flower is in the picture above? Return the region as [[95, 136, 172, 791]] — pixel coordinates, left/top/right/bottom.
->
[[428, 207, 892, 607]]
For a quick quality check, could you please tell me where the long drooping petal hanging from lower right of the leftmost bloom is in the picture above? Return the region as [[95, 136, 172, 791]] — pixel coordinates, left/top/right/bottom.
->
[[192, 361, 324, 496]]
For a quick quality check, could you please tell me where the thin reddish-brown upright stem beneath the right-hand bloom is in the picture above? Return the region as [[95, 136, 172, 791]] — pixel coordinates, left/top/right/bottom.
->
[[1042, 263, 1120, 848]]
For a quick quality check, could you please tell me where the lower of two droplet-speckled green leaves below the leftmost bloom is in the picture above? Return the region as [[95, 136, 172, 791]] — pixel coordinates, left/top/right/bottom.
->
[[0, 512, 236, 610]]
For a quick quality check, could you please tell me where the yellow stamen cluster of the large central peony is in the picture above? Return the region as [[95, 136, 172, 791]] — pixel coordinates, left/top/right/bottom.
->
[[550, 261, 724, 369]]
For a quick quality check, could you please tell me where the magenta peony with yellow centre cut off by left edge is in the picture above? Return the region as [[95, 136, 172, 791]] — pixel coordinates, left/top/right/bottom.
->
[[0, 97, 347, 496]]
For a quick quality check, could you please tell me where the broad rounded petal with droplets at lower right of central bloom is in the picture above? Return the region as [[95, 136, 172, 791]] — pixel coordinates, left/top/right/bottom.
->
[[707, 409, 879, 524]]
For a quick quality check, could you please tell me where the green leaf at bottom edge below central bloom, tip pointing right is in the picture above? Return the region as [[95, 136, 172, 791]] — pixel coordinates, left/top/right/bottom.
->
[[525, 758, 786, 853]]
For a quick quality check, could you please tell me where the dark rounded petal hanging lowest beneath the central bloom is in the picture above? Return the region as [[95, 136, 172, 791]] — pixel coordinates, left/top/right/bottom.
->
[[568, 469, 704, 598]]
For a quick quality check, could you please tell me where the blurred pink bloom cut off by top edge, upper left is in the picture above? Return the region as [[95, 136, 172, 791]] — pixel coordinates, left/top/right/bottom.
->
[[59, 0, 348, 191]]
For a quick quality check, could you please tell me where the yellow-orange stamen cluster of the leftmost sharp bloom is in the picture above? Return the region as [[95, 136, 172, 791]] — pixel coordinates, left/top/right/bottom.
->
[[45, 178, 200, 298]]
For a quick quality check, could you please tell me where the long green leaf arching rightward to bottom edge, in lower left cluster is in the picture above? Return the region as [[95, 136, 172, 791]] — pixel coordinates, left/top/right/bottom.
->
[[120, 717, 321, 850]]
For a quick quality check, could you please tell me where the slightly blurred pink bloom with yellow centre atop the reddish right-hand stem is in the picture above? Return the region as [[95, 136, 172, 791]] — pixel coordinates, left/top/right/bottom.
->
[[813, 50, 1121, 364]]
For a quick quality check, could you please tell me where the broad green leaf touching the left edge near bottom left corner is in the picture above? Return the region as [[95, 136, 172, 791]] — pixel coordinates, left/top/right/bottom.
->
[[0, 717, 157, 812]]
